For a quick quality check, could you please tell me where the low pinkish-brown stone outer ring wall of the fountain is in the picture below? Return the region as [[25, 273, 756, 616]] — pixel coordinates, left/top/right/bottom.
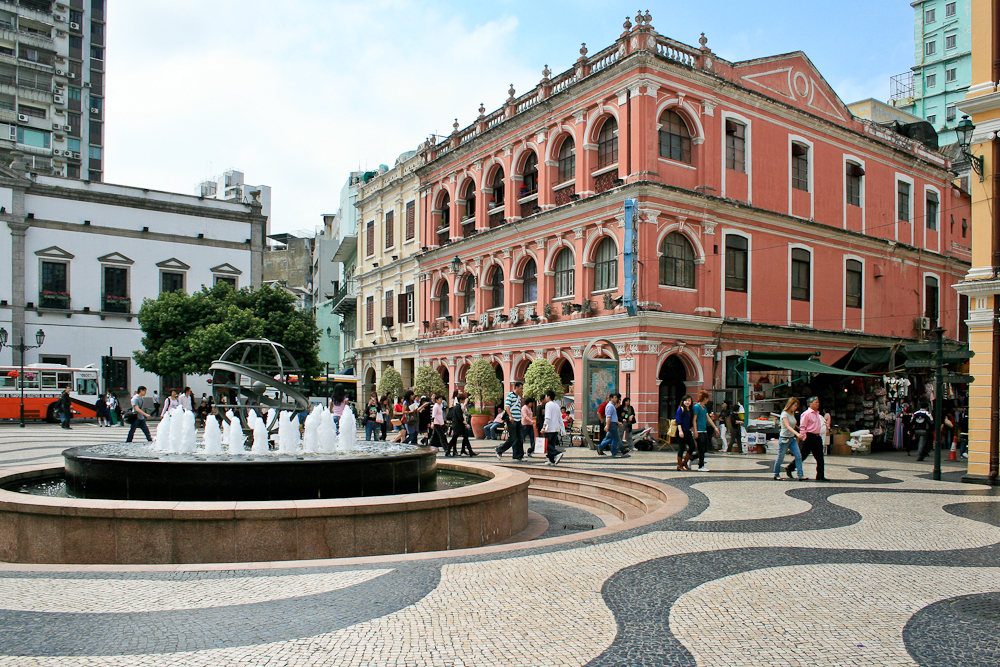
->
[[0, 462, 529, 565]]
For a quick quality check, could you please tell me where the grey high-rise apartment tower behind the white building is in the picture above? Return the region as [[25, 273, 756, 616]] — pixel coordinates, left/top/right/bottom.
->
[[0, 0, 106, 181]]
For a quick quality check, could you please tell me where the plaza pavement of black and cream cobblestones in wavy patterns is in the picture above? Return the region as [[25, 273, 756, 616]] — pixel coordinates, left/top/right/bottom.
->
[[0, 424, 1000, 667]]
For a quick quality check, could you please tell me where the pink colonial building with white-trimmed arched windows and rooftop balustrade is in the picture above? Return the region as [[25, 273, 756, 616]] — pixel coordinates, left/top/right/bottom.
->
[[404, 13, 970, 434]]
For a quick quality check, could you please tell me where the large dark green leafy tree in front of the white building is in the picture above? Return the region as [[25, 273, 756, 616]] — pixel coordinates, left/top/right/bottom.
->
[[133, 282, 320, 375]]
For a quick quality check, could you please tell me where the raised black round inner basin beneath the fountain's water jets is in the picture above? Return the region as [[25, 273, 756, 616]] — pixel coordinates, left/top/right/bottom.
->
[[63, 445, 437, 501]]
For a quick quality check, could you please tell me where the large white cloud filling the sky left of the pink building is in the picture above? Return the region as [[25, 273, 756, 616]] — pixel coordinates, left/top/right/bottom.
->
[[105, 0, 539, 231]]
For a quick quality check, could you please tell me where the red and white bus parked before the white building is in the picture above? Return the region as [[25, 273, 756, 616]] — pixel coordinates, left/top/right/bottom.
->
[[0, 364, 101, 422]]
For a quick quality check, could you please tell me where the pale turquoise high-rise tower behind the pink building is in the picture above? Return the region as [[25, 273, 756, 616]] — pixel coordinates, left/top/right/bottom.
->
[[891, 0, 972, 146]]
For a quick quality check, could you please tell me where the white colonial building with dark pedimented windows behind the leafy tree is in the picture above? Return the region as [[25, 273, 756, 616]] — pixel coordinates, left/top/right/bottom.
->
[[0, 155, 266, 394]]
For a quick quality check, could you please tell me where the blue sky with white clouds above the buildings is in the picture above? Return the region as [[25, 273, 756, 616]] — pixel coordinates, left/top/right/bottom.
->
[[105, 0, 913, 232]]
